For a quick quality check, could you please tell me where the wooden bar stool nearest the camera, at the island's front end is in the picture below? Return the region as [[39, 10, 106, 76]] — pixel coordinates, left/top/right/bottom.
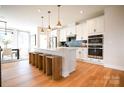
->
[[46, 55, 62, 80]]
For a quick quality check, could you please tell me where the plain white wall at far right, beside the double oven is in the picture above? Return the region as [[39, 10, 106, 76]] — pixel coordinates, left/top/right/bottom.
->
[[104, 6, 124, 70]]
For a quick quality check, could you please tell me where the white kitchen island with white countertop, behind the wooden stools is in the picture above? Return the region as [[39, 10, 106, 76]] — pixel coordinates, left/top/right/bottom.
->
[[35, 47, 76, 77]]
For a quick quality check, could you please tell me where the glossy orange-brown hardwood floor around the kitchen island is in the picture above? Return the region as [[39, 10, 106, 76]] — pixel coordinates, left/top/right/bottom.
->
[[2, 61, 124, 87]]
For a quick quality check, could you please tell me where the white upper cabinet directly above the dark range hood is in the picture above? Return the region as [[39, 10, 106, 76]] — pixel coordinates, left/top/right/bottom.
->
[[66, 24, 76, 36]]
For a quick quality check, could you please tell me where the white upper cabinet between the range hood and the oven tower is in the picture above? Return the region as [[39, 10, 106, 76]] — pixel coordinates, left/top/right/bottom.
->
[[76, 22, 88, 40]]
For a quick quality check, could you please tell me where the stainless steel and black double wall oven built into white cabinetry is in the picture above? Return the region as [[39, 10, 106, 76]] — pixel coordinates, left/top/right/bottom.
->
[[88, 34, 103, 59]]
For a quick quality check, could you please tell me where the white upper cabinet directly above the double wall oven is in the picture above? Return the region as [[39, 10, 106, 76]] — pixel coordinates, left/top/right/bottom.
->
[[87, 16, 104, 34]]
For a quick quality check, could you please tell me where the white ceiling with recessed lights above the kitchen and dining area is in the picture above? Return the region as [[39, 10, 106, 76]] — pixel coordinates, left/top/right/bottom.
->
[[0, 5, 108, 31]]
